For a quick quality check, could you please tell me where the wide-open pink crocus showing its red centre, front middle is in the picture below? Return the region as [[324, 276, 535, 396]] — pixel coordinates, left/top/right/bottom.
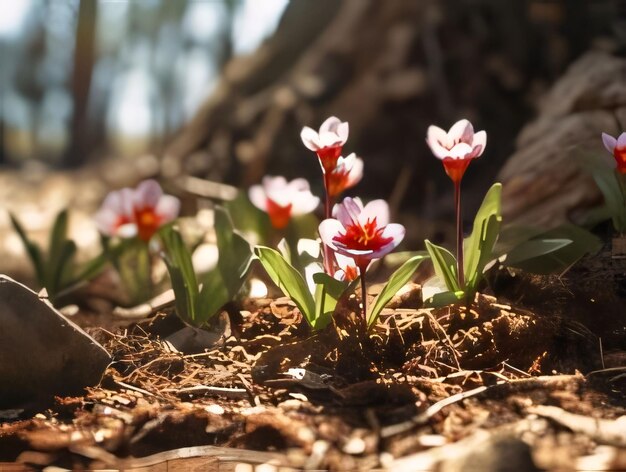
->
[[319, 197, 405, 275]]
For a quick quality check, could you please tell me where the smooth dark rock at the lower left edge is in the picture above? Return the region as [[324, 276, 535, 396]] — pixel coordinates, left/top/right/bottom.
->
[[0, 275, 111, 408]]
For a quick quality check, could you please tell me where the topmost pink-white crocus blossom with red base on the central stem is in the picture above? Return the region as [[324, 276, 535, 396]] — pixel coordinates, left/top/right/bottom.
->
[[300, 116, 349, 173]]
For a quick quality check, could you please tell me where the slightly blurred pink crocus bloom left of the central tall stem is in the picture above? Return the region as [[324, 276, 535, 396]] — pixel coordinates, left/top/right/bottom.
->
[[248, 176, 320, 229]]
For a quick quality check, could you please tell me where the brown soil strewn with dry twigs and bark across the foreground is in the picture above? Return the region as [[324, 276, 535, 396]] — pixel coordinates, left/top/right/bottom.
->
[[0, 252, 626, 471]]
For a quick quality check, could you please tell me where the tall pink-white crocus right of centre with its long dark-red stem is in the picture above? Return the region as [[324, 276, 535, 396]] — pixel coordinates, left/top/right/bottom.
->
[[426, 120, 487, 287]]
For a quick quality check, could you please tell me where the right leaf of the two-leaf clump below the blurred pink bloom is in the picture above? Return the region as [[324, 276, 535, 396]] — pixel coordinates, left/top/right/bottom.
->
[[215, 207, 252, 296]]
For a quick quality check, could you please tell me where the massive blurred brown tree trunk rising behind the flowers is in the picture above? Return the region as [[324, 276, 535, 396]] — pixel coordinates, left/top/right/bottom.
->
[[164, 0, 610, 241]]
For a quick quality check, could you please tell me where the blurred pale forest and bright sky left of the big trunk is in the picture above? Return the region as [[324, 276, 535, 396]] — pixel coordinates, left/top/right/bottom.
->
[[0, 0, 287, 166]]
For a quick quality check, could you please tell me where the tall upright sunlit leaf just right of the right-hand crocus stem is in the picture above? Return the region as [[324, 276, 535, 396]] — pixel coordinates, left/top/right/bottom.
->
[[464, 183, 502, 298]]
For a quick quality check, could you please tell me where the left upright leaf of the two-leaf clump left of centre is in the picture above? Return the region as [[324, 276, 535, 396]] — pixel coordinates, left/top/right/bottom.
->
[[158, 227, 199, 326]]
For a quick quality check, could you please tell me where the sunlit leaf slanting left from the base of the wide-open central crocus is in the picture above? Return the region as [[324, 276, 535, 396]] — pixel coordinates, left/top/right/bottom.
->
[[254, 246, 315, 326]]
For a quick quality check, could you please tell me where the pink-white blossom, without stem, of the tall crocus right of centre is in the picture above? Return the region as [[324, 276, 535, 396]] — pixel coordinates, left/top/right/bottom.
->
[[426, 120, 487, 184]]
